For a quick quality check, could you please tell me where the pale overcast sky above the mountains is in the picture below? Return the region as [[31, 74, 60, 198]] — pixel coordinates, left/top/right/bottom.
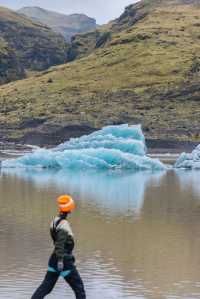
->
[[0, 0, 137, 24]]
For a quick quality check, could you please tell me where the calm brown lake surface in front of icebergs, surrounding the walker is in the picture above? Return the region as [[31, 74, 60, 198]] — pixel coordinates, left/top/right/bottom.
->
[[0, 170, 200, 299]]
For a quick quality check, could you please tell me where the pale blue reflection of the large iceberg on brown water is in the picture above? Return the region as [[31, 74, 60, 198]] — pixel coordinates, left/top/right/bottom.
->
[[2, 169, 165, 215]]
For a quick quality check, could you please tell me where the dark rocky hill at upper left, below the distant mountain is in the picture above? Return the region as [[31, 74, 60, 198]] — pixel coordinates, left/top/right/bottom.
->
[[0, 7, 67, 83]]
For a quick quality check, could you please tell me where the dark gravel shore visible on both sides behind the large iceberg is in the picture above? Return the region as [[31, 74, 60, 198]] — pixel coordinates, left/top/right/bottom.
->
[[0, 124, 200, 154]]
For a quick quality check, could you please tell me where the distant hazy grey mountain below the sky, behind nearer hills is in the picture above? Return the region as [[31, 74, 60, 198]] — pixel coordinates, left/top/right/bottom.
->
[[18, 7, 96, 42]]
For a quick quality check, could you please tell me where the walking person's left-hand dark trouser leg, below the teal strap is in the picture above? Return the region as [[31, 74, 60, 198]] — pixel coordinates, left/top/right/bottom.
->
[[31, 272, 59, 299]]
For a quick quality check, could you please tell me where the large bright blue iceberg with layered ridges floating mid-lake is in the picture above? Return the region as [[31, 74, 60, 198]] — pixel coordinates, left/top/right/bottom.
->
[[2, 124, 166, 170]]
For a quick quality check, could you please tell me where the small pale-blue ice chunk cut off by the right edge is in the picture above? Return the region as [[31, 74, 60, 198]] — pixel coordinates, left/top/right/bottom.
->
[[175, 144, 200, 169]]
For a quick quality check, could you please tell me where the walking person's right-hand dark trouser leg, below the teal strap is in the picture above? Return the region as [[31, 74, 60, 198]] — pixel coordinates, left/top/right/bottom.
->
[[64, 267, 86, 299]]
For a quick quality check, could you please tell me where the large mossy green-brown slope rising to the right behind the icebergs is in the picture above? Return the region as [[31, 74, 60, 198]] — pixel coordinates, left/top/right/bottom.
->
[[0, 1, 200, 144]]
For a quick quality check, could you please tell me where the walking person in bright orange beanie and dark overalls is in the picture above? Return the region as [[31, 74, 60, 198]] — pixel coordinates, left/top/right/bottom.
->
[[31, 195, 86, 299]]
